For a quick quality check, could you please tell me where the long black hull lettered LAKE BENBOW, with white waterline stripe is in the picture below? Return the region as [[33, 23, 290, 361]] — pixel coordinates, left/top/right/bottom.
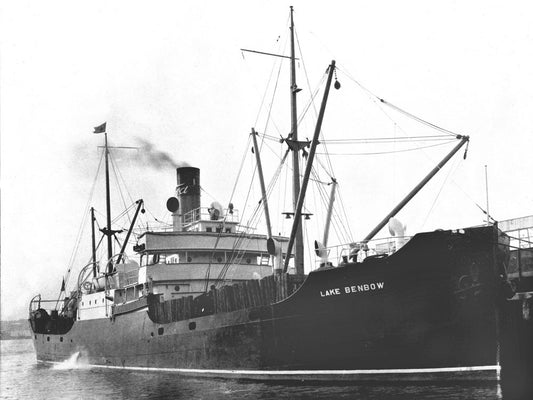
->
[[34, 227, 505, 381]]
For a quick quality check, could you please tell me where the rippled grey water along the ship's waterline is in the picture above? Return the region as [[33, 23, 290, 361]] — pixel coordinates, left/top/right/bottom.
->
[[0, 340, 508, 400]]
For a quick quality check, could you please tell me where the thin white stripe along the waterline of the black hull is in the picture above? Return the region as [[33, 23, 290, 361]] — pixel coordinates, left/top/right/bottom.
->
[[37, 360, 501, 376]]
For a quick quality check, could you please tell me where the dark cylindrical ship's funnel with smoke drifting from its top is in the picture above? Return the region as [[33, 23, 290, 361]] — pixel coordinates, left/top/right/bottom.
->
[[176, 167, 200, 224]]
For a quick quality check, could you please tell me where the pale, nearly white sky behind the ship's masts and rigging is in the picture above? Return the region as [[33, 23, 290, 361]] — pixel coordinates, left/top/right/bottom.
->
[[0, 0, 533, 320]]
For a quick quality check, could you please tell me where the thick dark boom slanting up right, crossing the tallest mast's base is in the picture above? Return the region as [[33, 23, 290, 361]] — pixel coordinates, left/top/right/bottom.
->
[[283, 60, 335, 274]]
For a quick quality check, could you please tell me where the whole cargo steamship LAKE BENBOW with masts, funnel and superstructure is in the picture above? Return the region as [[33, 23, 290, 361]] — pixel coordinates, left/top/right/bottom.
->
[[29, 8, 514, 381]]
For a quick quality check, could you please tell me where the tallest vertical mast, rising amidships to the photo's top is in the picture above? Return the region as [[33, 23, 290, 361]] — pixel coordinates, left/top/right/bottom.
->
[[287, 6, 304, 275]]
